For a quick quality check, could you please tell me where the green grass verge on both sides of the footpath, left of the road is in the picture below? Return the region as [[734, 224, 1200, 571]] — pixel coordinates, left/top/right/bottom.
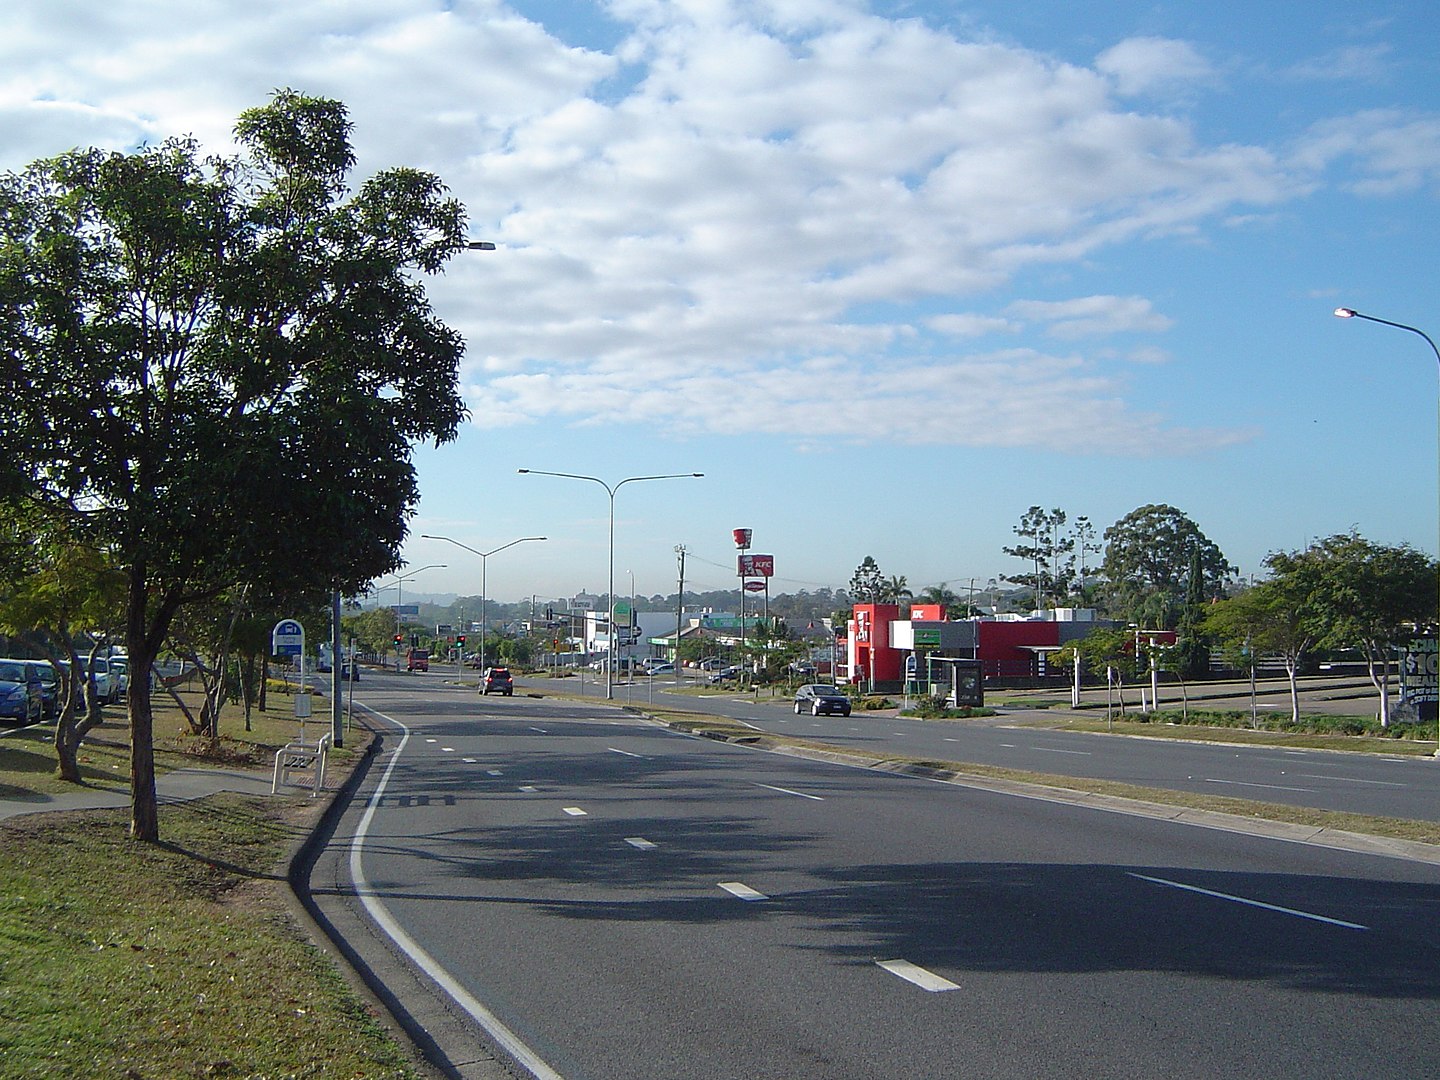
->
[[0, 685, 422, 1080]]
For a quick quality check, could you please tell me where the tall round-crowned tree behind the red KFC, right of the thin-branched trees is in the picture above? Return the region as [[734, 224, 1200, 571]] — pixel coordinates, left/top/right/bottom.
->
[[1100, 504, 1234, 629]]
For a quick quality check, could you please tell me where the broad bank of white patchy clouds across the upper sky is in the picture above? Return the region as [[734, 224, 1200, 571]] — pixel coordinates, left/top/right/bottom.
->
[[0, 0, 1426, 452]]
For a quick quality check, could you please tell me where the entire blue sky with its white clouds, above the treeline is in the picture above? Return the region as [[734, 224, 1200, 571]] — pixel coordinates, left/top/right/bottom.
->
[[0, 0, 1440, 600]]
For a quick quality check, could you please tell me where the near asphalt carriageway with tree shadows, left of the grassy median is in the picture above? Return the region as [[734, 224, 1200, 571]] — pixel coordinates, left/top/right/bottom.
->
[[317, 677, 1440, 1080]]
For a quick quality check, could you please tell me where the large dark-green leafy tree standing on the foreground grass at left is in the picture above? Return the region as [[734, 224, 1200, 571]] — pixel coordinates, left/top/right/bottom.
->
[[0, 91, 465, 840]]
